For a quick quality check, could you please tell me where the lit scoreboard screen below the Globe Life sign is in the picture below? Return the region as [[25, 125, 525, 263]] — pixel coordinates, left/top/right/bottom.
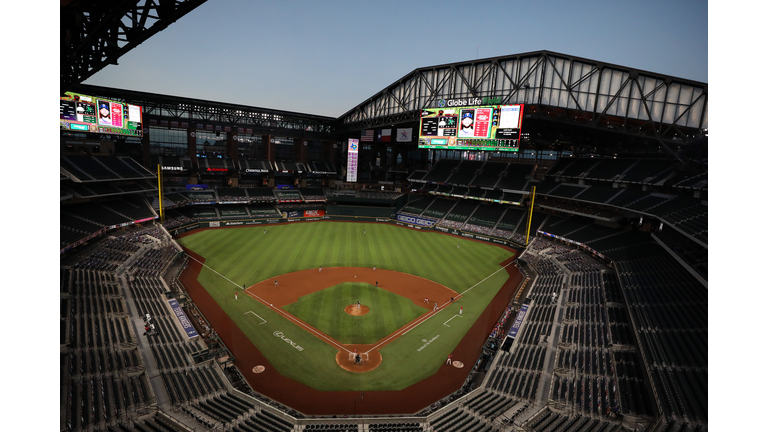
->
[[419, 101, 523, 151]]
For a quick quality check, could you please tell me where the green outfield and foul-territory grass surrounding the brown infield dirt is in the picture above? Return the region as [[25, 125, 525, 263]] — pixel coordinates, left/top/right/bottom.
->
[[179, 221, 512, 391]]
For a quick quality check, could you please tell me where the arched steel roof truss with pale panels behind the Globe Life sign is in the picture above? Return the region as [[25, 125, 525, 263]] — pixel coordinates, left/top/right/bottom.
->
[[338, 51, 708, 148]]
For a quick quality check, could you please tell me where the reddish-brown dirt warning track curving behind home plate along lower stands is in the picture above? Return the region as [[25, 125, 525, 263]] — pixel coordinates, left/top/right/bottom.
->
[[180, 248, 523, 415]]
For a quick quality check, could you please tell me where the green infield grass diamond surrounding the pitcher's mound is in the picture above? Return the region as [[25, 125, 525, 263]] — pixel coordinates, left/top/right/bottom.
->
[[283, 282, 428, 344]]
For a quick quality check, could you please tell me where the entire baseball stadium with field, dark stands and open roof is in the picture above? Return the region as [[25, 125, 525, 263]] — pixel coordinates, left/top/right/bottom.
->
[[59, 0, 708, 432]]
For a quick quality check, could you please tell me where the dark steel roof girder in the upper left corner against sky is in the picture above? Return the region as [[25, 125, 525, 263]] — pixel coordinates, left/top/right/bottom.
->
[[59, 0, 205, 93]]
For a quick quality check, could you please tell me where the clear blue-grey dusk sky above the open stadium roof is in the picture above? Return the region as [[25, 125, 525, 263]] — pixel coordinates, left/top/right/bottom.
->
[[85, 0, 708, 117]]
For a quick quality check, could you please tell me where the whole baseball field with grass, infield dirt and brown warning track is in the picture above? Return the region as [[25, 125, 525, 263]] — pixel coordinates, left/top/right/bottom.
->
[[178, 221, 514, 414]]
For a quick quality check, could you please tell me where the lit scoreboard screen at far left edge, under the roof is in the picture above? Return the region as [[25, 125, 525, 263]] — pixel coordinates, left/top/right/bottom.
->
[[59, 92, 143, 137]]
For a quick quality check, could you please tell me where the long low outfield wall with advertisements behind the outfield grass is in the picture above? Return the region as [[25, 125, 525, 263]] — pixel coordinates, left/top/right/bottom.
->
[[168, 213, 524, 249]]
